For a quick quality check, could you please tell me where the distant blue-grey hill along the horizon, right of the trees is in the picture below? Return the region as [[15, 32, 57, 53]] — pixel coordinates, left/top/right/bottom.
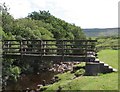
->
[[82, 28, 118, 37]]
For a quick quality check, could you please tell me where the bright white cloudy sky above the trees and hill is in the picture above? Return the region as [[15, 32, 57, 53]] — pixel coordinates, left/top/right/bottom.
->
[[0, 0, 119, 28]]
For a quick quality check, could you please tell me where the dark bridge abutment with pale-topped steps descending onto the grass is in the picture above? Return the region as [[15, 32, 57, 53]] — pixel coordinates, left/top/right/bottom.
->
[[85, 59, 117, 76]]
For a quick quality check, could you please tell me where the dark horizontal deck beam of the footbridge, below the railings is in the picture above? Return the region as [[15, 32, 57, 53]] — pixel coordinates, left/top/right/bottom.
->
[[3, 54, 95, 62]]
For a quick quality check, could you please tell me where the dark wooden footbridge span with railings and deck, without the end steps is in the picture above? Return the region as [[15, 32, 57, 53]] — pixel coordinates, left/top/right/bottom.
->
[[2, 40, 97, 62]]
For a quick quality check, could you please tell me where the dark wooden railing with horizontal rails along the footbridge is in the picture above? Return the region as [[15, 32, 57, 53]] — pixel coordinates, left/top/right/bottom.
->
[[2, 40, 96, 56]]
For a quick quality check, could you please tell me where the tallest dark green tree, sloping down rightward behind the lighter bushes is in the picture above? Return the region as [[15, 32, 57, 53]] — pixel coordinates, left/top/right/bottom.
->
[[28, 11, 85, 39]]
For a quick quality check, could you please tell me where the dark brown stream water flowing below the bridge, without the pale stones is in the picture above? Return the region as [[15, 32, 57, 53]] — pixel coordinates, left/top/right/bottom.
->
[[6, 71, 57, 90]]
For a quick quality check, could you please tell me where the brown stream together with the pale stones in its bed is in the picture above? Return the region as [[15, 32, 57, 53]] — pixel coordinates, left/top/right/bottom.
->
[[6, 62, 79, 90]]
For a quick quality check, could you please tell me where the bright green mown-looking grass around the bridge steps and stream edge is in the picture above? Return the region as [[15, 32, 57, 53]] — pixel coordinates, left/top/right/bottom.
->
[[41, 50, 118, 92]]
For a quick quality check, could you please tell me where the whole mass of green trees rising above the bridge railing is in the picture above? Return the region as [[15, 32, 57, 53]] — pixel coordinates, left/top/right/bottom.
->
[[0, 5, 86, 40]]
